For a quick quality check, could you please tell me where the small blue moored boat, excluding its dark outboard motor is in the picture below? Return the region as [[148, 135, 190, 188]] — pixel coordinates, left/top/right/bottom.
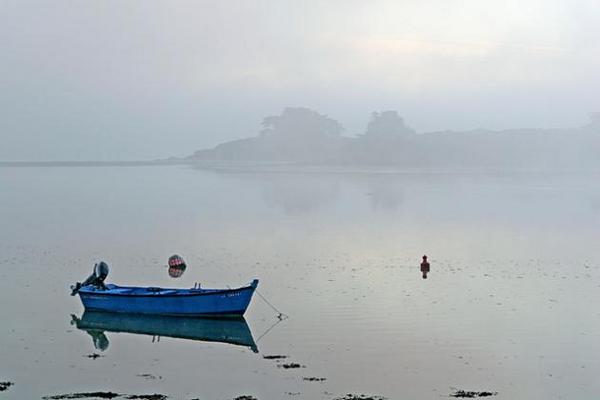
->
[[73, 279, 258, 317]]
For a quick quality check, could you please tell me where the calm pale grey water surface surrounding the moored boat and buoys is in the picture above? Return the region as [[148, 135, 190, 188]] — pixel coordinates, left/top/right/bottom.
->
[[0, 167, 600, 400]]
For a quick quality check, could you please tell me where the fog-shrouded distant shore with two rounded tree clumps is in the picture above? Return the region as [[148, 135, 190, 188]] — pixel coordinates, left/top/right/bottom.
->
[[187, 107, 600, 168]]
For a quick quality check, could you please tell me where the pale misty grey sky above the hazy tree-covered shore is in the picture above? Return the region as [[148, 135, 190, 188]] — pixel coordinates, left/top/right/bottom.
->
[[0, 0, 600, 161]]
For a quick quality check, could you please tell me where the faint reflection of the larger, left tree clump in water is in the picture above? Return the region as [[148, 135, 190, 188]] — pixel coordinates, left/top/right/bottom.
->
[[263, 175, 340, 215]]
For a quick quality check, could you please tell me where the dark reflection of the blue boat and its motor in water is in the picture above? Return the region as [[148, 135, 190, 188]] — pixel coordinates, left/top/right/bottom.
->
[[71, 311, 258, 353]]
